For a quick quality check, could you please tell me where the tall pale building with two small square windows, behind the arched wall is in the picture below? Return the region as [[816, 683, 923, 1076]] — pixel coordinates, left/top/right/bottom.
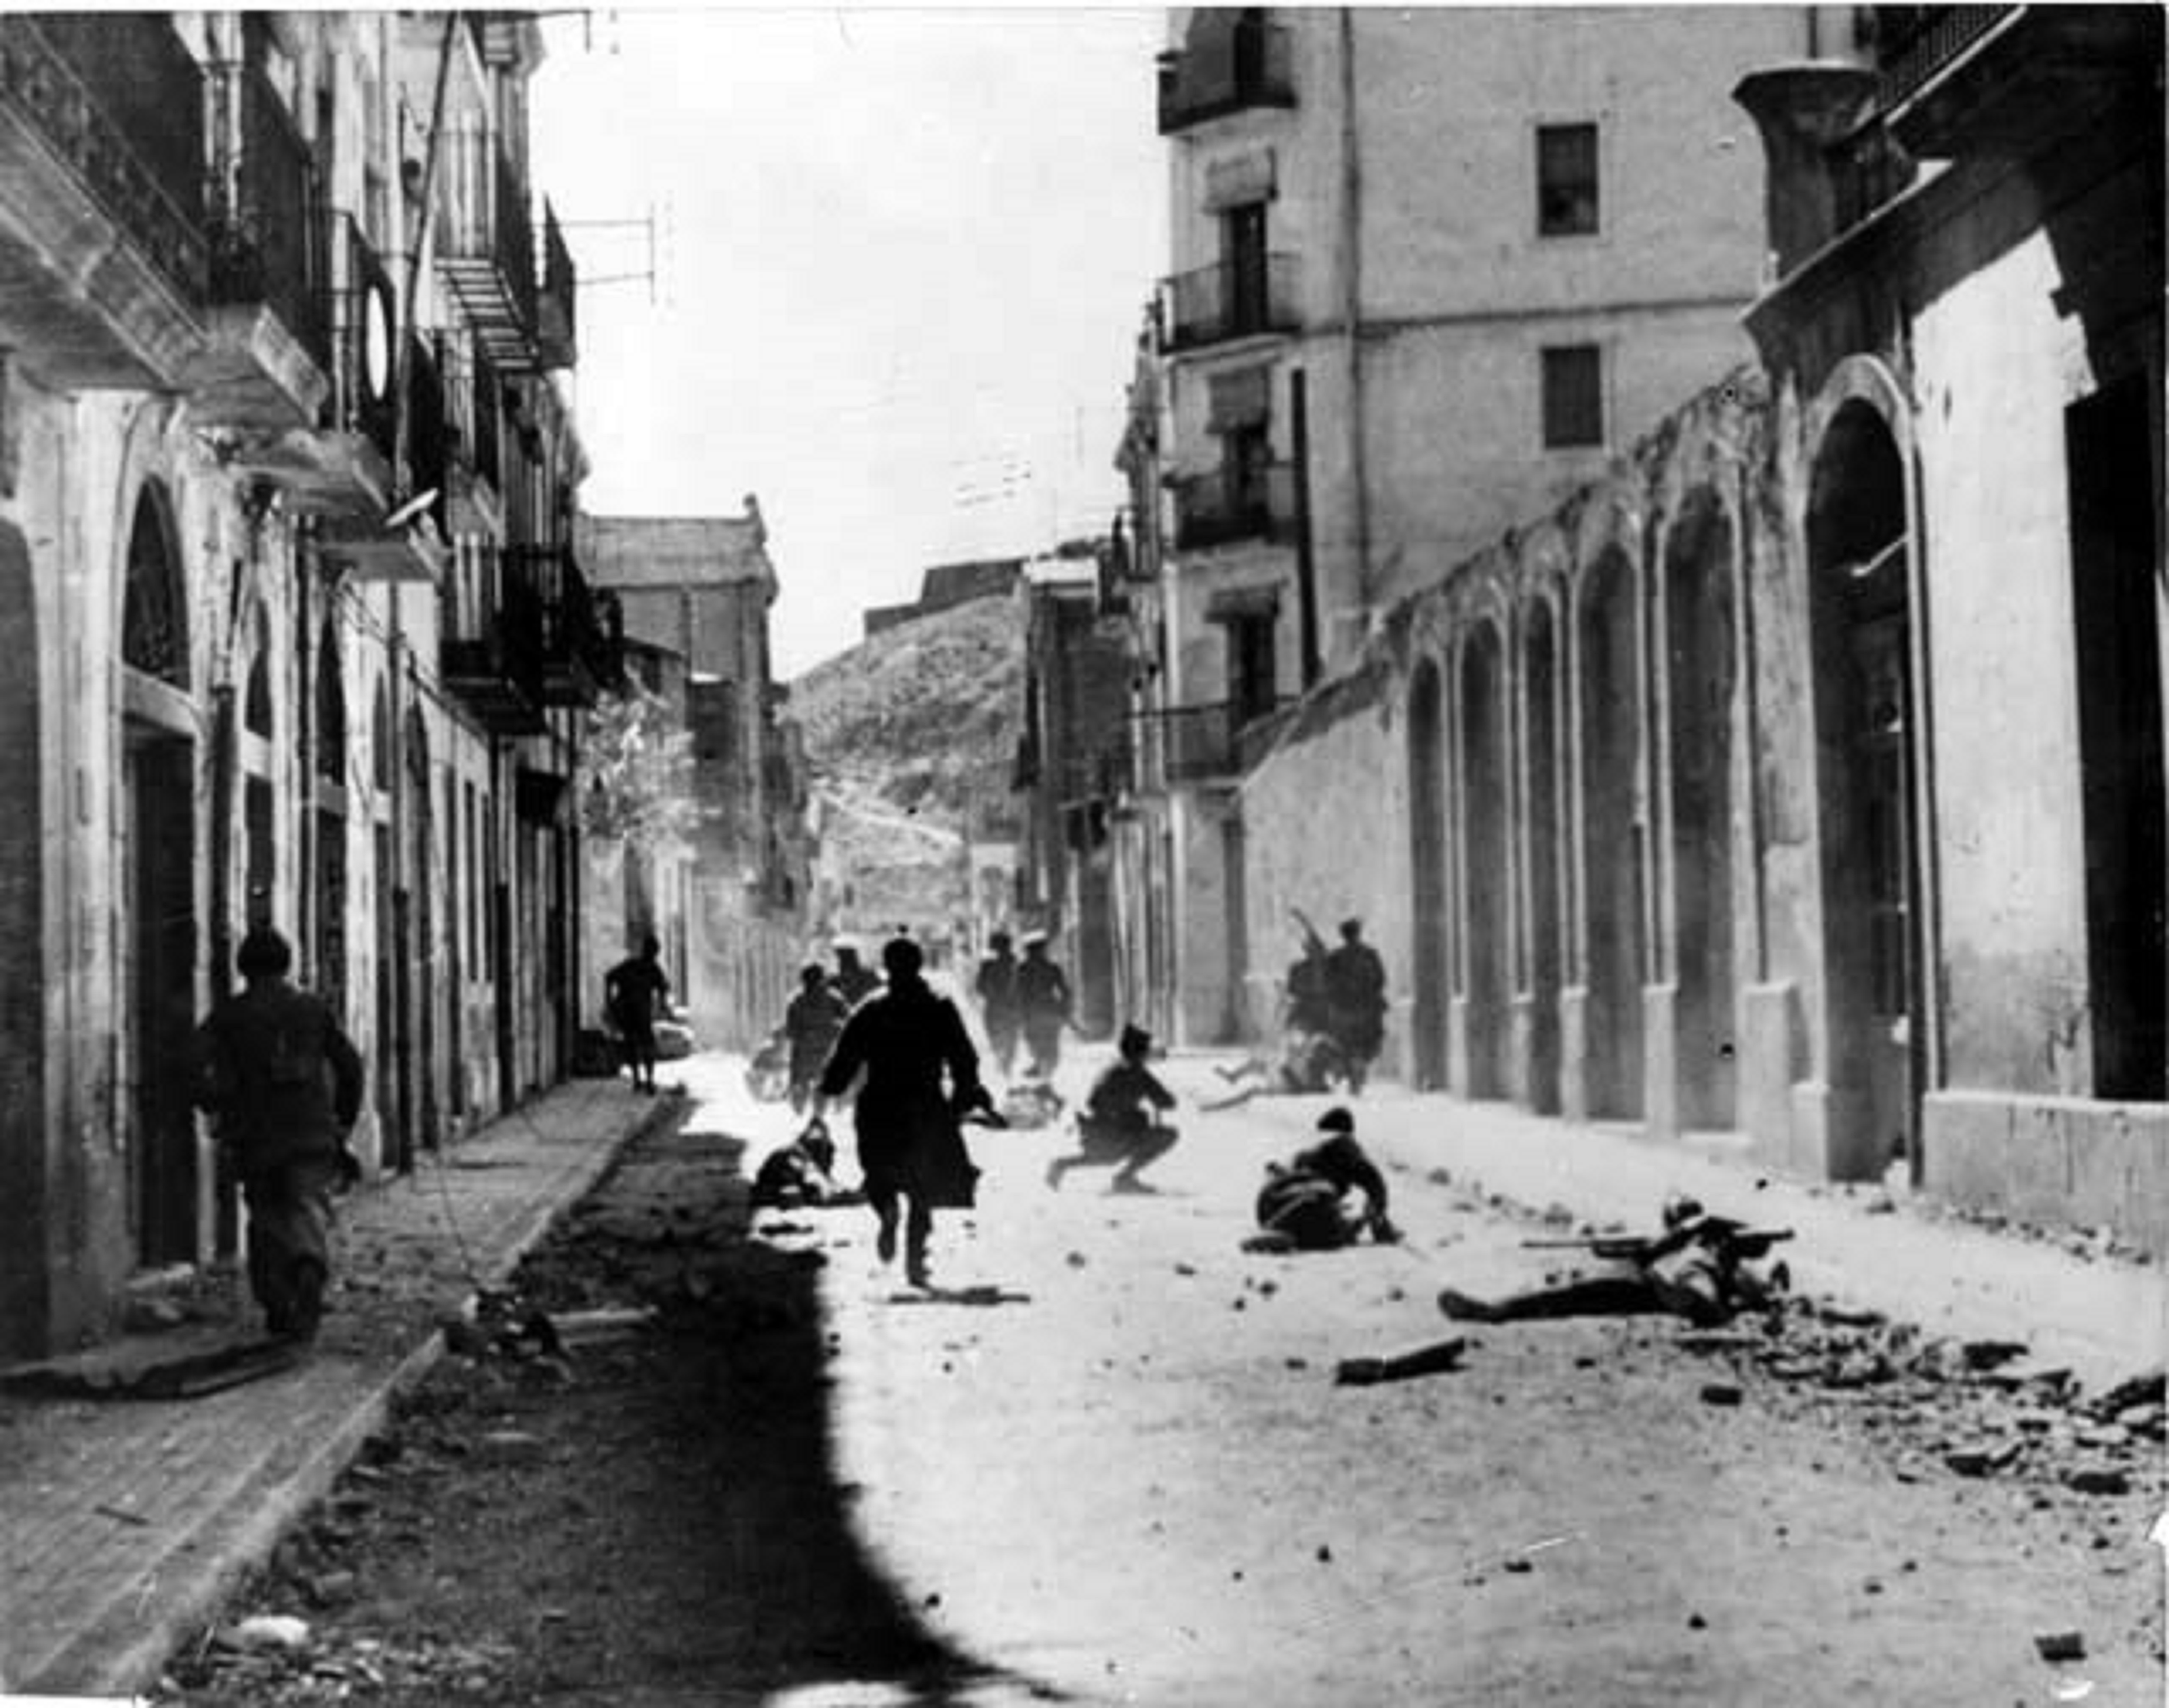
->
[[1119, 6, 1818, 1038]]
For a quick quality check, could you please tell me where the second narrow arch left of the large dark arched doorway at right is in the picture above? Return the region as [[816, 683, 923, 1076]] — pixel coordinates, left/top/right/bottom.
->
[[1579, 548, 1642, 1121]]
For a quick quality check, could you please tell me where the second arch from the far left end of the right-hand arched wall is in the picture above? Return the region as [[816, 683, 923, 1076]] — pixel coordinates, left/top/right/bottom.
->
[[1460, 622, 1512, 1097]]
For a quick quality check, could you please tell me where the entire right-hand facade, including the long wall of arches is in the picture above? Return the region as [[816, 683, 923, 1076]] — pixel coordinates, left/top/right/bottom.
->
[[1238, 6, 2169, 1250]]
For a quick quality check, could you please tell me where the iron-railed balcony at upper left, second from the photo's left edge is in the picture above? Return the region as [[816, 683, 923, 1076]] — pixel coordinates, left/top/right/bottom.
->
[[186, 65, 332, 431]]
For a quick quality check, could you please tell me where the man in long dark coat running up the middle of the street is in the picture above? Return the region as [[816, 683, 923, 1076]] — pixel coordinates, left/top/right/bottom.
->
[[813, 936, 993, 1287]]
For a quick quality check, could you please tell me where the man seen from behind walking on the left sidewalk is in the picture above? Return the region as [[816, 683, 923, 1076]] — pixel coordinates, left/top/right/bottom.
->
[[195, 926, 362, 1342]]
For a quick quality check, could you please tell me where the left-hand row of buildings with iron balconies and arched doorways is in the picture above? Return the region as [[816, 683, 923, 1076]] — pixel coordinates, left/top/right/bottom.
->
[[0, 13, 614, 1350]]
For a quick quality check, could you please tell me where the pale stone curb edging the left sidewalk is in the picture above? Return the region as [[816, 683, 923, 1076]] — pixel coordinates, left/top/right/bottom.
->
[[42, 1097, 690, 1693]]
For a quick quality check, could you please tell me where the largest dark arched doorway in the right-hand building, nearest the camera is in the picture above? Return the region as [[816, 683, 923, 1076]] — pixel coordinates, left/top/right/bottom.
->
[[1807, 399, 1920, 1177]]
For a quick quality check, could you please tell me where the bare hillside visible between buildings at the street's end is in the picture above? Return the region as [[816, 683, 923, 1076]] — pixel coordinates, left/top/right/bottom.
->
[[792, 594, 1024, 928]]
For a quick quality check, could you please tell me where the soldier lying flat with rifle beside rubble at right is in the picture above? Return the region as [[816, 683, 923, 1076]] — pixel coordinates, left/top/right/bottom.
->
[[1438, 1197, 1791, 1329]]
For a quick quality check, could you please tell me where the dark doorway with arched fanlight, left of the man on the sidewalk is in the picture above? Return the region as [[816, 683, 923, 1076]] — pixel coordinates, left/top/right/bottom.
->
[[119, 481, 200, 1266]]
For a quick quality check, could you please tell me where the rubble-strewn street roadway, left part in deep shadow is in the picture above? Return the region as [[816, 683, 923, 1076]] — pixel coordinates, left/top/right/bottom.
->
[[169, 1058, 2163, 1708]]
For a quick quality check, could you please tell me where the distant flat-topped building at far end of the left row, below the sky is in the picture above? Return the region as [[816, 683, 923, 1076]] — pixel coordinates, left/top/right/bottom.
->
[[579, 496, 811, 1049]]
